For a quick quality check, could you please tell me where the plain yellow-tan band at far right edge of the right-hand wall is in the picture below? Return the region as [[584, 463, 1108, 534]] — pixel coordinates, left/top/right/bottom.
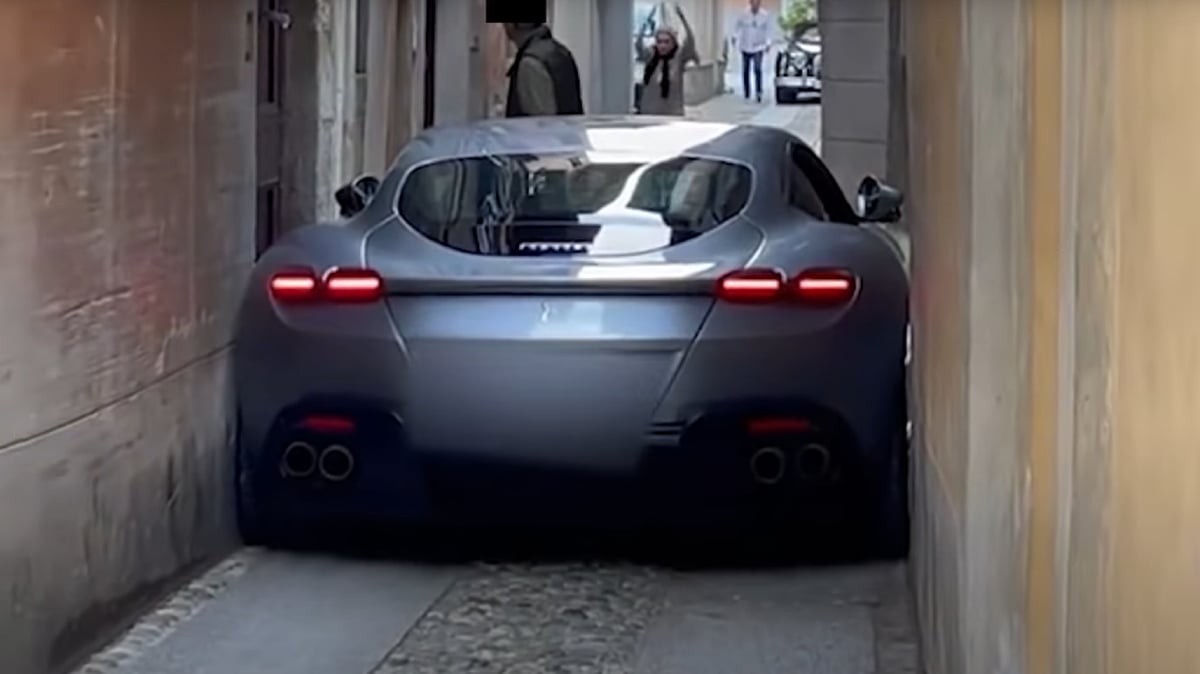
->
[[1104, 0, 1200, 674]]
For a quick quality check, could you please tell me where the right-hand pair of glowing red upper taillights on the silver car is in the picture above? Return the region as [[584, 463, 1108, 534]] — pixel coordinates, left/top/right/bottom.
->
[[716, 269, 858, 305]]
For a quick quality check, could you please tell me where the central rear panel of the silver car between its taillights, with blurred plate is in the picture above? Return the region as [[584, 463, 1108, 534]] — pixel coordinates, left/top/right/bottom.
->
[[390, 295, 713, 471]]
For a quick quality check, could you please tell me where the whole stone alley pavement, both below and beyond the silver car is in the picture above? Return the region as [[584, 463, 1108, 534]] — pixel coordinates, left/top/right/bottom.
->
[[72, 96, 918, 674]]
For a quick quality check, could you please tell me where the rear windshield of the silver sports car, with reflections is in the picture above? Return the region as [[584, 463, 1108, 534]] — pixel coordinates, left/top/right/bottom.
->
[[398, 154, 752, 255]]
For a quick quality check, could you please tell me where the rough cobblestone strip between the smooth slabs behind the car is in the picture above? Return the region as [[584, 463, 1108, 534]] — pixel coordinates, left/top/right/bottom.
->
[[373, 564, 664, 674]]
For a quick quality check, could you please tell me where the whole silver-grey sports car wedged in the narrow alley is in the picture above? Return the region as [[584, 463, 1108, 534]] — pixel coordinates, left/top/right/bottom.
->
[[235, 116, 908, 554]]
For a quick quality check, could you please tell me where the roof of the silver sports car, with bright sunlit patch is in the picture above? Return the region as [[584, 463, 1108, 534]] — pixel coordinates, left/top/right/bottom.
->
[[398, 115, 779, 166]]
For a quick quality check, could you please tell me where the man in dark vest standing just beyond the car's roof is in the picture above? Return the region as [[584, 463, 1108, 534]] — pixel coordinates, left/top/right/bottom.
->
[[504, 23, 583, 118]]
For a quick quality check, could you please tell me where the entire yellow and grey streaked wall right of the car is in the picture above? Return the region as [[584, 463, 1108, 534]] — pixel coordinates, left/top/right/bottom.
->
[[906, 0, 1200, 674]]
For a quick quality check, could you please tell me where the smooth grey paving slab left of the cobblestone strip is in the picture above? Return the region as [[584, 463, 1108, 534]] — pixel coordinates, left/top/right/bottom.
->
[[79, 553, 461, 674]]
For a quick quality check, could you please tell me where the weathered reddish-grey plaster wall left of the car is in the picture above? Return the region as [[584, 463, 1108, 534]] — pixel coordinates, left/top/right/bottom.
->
[[0, 0, 254, 674]]
